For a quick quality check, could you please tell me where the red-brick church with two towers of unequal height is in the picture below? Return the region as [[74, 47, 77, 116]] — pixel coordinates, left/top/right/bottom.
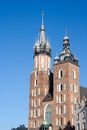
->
[[28, 13, 80, 130]]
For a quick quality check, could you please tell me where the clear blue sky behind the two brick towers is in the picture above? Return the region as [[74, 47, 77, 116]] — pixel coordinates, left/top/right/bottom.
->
[[0, 0, 87, 130]]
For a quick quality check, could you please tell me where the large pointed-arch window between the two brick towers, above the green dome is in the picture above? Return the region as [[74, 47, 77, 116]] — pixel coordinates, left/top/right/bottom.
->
[[45, 104, 52, 123]]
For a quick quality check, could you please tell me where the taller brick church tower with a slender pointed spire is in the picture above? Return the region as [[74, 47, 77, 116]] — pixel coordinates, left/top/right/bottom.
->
[[29, 13, 53, 130]]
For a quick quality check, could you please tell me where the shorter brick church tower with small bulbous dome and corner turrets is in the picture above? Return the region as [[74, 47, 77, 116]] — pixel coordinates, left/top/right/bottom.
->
[[53, 36, 80, 130]]
